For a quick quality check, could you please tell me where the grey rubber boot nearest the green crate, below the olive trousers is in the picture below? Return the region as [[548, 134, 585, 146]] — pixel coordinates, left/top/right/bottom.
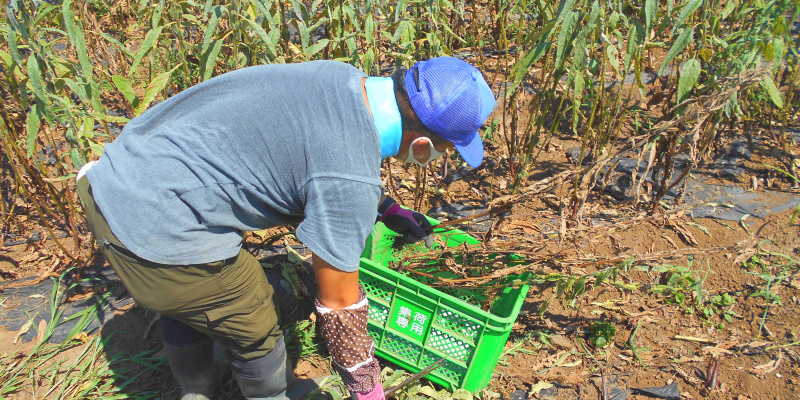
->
[[229, 337, 329, 400]]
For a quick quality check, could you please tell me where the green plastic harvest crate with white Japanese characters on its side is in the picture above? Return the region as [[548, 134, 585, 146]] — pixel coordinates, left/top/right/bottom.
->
[[360, 220, 529, 392]]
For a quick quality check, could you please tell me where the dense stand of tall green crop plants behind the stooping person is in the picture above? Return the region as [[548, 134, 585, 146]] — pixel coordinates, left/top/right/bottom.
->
[[0, 0, 798, 259]]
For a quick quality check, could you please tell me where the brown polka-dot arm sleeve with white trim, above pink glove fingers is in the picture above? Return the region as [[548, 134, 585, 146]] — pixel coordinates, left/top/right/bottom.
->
[[314, 285, 381, 393]]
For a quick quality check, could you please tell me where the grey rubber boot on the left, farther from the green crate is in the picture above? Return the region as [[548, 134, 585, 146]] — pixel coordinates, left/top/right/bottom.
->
[[164, 338, 220, 400]]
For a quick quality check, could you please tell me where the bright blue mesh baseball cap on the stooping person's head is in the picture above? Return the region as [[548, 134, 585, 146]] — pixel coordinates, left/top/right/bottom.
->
[[405, 57, 495, 168]]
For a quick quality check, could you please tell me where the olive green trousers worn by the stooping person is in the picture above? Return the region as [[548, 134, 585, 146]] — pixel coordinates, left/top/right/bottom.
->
[[78, 177, 281, 360]]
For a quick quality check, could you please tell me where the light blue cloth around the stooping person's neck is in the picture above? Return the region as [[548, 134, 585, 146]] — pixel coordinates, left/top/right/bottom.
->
[[364, 77, 403, 159]]
